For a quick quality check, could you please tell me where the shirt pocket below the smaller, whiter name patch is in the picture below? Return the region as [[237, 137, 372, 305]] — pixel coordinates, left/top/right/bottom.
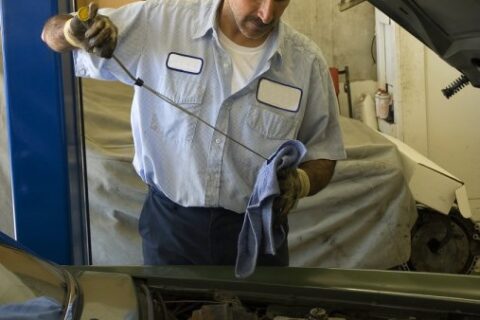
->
[[158, 71, 206, 143]]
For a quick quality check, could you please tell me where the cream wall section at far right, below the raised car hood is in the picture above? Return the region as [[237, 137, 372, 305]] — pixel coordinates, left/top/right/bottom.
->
[[395, 26, 480, 216]]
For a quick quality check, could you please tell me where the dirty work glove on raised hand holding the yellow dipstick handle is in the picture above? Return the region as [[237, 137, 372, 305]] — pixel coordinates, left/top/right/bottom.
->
[[63, 2, 118, 58]]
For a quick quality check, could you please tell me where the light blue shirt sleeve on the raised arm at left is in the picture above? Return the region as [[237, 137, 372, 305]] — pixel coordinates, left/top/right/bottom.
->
[[73, 1, 149, 85]]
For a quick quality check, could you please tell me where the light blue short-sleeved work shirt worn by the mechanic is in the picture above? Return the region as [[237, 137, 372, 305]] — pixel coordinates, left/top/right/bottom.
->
[[74, 0, 345, 213]]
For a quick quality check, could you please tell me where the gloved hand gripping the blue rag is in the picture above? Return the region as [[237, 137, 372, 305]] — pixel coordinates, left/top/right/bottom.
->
[[273, 168, 310, 223]]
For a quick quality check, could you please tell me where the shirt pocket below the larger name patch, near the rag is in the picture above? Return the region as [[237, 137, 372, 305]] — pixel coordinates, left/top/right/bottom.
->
[[247, 101, 298, 140]]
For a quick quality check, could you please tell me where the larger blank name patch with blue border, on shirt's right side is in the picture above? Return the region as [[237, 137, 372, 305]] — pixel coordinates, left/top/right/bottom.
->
[[257, 78, 303, 112]]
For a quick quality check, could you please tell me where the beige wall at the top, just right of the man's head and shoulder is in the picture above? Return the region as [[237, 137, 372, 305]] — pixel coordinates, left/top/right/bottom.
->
[[285, 0, 376, 81]]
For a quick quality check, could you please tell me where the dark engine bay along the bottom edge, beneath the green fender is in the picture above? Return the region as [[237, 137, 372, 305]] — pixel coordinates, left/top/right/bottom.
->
[[142, 286, 480, 320]]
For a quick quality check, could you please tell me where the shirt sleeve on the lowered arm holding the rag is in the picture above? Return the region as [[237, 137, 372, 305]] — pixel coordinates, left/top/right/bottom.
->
[[298, 55, 346, 161]]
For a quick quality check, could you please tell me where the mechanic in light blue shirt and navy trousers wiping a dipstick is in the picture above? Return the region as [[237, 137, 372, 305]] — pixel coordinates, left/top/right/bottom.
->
[[42, 0, 345, 266]]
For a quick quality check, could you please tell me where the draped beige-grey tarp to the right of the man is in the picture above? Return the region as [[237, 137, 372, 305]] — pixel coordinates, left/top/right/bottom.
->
[[289, 118, 417, 269]]
